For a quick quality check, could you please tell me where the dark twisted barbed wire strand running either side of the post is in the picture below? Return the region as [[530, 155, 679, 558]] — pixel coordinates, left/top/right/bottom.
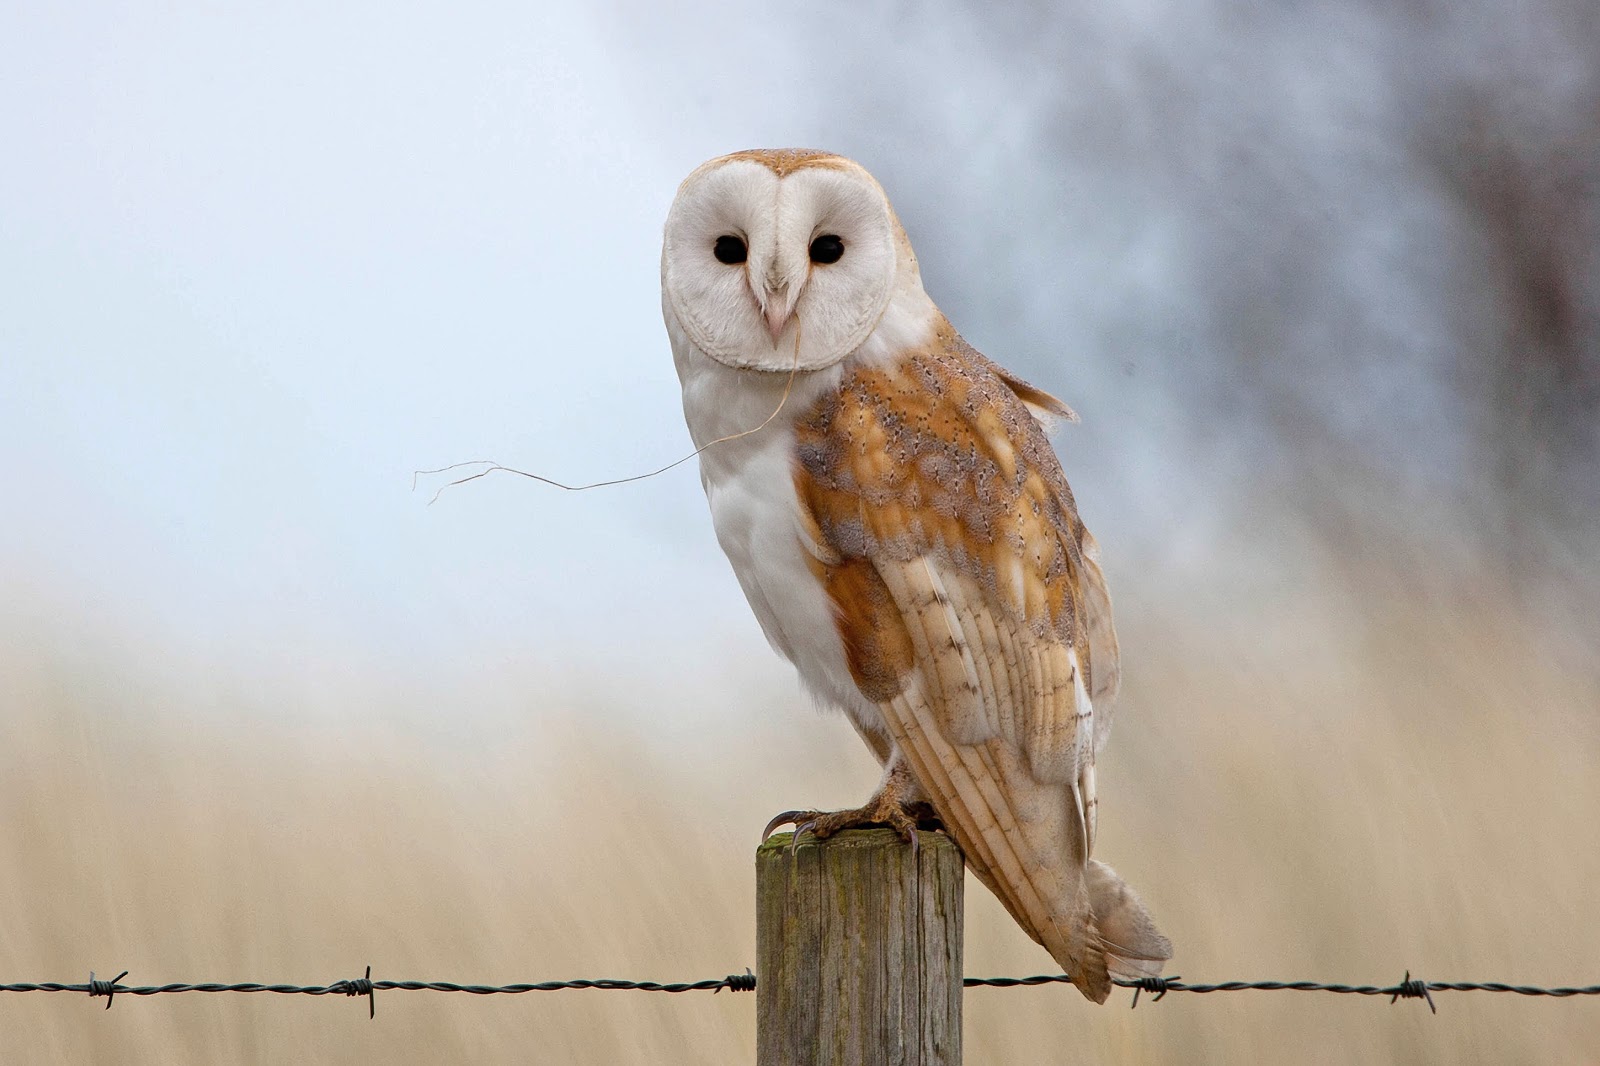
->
[[0, 967, 1600, 1018]]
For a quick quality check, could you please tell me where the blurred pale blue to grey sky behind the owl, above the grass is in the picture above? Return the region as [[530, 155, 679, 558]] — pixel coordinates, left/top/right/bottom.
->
[[0, 2, 1600, 717]]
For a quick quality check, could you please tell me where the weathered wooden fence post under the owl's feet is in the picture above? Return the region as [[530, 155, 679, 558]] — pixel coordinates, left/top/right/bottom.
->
[[755, 829, 963, 1066]]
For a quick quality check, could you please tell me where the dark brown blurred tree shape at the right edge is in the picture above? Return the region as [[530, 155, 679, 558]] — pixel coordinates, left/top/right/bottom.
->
[[1418, 82, 1600, 557]]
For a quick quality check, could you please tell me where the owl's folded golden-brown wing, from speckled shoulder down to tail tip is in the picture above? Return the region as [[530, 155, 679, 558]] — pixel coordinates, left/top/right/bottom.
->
[[795, 320, 1166, 1000]]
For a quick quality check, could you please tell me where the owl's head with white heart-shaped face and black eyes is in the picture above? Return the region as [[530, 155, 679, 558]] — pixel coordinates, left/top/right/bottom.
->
[[661, 149, 909, 370]]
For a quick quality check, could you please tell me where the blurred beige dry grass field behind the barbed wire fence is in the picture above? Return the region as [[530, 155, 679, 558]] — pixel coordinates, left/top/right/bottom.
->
[[0, 569, 1600, 1064]]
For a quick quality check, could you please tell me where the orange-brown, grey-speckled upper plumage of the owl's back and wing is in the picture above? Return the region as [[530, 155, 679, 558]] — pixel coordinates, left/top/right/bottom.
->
[[795, 315, 1117, 698]]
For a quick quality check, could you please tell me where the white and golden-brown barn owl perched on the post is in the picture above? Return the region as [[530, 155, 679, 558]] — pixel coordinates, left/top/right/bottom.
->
[[661, 150, 1171, 1002]]
